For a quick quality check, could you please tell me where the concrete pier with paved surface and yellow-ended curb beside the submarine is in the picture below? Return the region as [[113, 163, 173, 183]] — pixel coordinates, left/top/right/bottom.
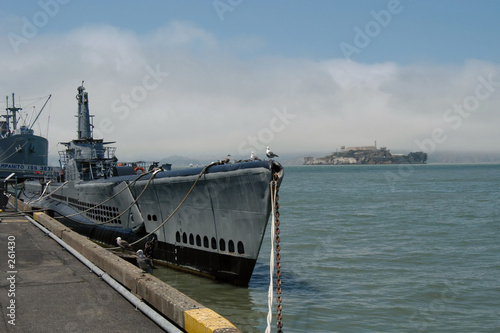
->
[[0, 197, 239, 333]]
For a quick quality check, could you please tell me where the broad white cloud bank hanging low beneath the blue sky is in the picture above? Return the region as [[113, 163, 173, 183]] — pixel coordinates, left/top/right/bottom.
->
[[0, 22, 500, 163]]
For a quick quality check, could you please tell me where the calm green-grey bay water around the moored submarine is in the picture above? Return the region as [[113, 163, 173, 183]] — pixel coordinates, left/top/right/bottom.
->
[[155, 164, 500, 332]]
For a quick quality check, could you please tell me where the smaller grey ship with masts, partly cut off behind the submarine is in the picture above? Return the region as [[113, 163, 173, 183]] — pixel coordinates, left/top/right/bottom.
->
[[0, 94, 51, 181]]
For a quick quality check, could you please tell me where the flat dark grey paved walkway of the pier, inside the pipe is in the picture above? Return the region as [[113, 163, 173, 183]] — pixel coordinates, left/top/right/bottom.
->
[[0, 206, 168, 333]]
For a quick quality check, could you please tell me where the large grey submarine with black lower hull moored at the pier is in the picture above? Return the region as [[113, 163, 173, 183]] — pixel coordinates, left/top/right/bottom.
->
[[22, 84, 283, 286]]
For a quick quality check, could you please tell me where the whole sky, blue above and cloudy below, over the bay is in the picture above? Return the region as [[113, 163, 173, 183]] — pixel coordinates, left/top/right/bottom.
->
[[0, 0, 500, 160]]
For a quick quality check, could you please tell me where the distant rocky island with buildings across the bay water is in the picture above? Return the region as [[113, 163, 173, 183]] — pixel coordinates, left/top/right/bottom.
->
[[304, 145, 427, 165]]
